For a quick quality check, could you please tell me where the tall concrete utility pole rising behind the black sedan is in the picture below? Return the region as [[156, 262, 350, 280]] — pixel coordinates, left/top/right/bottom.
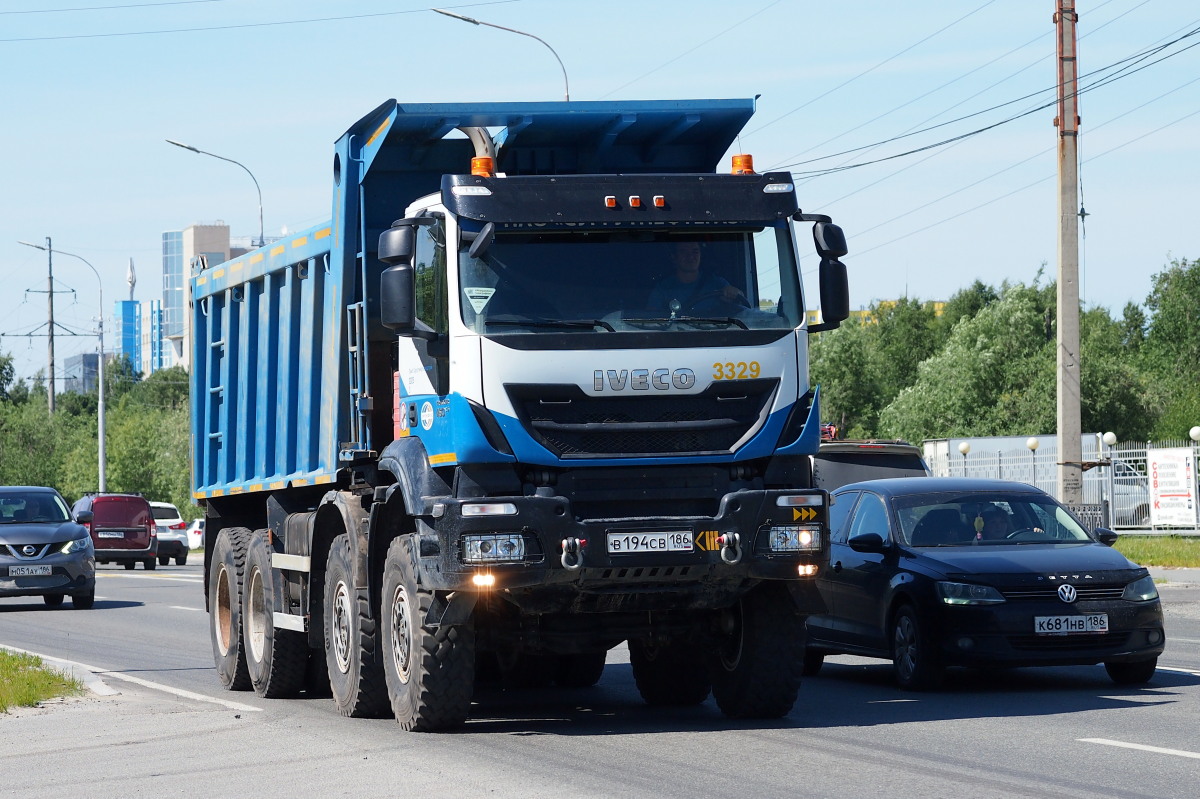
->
[[1054, 0, 1084, 505]]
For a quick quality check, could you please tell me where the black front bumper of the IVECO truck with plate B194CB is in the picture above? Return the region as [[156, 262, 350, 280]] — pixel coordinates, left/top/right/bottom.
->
[[418, 489, 829, 613]]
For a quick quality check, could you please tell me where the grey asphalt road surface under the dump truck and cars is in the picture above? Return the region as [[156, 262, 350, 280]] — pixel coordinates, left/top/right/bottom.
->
[[0, 564, 1200, 799]]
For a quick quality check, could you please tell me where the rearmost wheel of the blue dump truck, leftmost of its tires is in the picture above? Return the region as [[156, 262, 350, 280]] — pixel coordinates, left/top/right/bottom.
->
[[209, 527, 251, 691]]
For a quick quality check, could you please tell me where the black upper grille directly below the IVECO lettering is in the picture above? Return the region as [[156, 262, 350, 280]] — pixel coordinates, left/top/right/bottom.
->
[[505, 379, 779, 458]]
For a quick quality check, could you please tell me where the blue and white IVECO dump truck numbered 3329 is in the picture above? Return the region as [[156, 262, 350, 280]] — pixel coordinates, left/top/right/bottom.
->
[[190, 100, 848, 731]]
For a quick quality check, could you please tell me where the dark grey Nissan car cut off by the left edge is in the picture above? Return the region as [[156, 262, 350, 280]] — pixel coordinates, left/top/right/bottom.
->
[[0, 486, 96, 609]]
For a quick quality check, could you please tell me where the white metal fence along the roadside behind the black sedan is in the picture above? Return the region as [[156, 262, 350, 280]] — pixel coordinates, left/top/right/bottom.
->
[[926, 440, 1200, 533]]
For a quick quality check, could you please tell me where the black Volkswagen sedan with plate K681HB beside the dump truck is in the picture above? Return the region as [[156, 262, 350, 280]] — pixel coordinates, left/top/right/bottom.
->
[[805, 477, 1165, 690]]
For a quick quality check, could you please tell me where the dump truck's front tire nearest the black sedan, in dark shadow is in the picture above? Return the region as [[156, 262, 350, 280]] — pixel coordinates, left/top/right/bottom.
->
[[712, 584, 804, 719]]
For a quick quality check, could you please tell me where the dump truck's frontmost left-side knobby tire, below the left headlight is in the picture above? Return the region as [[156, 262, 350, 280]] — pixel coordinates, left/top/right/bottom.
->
[[379, 535, 475, 732]]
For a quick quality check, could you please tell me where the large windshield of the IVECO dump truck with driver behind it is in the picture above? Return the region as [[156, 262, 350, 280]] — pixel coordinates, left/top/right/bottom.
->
[[458, 222, 804, 336]]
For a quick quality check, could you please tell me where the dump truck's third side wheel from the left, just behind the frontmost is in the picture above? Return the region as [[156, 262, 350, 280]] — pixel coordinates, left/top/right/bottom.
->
[[324, 533, 388, 719]]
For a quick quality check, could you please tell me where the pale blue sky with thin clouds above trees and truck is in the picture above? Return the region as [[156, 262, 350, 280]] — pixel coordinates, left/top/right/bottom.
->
[[0, 0, 1200, 377]]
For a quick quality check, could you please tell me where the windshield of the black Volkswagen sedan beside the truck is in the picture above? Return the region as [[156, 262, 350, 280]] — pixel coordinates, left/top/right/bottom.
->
[[893, 492, 1093, 547]]
